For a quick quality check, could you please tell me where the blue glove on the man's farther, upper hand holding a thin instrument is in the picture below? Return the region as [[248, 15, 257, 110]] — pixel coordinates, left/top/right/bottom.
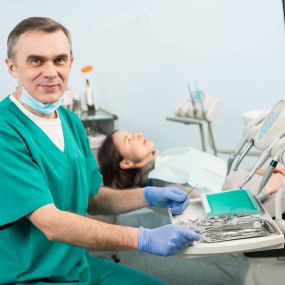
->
[[144, 186, 189, 215]]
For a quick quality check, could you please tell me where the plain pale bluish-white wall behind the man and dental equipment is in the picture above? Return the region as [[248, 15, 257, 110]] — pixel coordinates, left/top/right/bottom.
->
[[0, 0, 285, 154]]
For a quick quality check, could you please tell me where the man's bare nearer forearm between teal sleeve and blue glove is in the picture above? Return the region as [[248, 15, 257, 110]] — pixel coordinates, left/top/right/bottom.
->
[[27, 204, 138, 250]]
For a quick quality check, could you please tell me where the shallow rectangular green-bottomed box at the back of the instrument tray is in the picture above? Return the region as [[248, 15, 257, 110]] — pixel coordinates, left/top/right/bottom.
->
[[201, 189, 261, 217]]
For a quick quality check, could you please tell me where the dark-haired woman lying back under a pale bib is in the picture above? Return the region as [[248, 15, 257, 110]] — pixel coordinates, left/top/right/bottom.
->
[[98, 130, 285, 215]]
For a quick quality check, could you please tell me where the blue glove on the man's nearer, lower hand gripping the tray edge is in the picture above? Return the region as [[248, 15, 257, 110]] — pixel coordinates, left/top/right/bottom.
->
[[138, 225, 200, 256]]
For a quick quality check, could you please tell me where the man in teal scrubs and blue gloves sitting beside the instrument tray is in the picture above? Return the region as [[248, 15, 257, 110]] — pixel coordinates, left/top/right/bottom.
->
[[0, 17, 199, 284]]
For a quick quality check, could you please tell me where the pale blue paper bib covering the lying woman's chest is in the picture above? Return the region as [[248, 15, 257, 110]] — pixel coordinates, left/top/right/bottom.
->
[[148, 147, 227, 192]]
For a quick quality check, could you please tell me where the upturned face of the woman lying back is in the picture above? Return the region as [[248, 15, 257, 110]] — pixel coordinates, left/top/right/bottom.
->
[[113, 131, 154, 163]]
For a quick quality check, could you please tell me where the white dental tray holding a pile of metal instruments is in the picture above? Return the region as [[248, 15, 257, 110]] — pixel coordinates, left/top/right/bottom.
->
[[169, 195, 284, 255]]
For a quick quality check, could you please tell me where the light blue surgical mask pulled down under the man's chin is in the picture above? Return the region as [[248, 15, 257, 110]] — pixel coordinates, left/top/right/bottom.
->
[[19, 85, 62, 115]]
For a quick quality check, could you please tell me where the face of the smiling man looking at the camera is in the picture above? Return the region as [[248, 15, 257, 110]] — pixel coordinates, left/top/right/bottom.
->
[[6, 30, 73, 104]]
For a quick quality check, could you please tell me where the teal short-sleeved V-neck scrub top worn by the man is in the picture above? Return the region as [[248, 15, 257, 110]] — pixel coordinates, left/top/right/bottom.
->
[[0, 97, 102, 284]]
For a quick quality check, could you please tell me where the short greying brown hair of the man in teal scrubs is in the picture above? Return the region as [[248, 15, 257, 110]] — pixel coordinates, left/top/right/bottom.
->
[[7, 17, 72, 58]]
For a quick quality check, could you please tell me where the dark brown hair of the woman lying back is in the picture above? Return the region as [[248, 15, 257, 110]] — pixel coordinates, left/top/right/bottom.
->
[[98, 130, 154, 189]]
